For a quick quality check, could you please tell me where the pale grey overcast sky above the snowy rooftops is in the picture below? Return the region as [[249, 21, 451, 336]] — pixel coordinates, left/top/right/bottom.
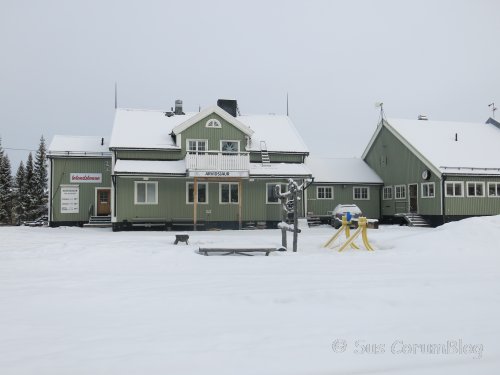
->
[[0, 0, 500, 173]]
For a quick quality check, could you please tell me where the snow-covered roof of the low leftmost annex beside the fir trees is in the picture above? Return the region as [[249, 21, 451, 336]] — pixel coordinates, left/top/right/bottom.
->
[[47, 135, 111, 156]]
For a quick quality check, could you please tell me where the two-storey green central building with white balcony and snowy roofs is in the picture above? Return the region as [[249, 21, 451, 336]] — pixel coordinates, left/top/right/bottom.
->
[[109, 100, 311, 230]]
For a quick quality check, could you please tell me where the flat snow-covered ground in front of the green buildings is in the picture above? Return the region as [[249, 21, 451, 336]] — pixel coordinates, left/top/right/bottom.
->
[[0, 216, 500, 375]]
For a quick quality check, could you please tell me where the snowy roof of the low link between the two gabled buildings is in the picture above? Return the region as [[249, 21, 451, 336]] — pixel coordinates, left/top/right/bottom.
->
[[306, 156, 383, 184]]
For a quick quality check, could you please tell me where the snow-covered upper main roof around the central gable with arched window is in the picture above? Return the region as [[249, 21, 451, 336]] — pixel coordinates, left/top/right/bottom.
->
[[110, 107, 308, 153]]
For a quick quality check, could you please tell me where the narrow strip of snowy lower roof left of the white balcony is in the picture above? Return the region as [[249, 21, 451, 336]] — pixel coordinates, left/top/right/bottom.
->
[[114, 159, 186, 175]]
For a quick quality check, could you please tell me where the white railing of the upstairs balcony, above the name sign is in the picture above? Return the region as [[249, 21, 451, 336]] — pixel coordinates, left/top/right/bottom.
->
[[186, 152, 250, 171]]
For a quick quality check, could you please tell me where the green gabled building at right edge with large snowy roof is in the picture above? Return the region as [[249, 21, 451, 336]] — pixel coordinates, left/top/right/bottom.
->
[[362, 117, 500, 225]]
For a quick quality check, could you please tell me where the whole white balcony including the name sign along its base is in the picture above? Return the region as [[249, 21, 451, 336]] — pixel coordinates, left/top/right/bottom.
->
[[186, 151, 250, 177]]
